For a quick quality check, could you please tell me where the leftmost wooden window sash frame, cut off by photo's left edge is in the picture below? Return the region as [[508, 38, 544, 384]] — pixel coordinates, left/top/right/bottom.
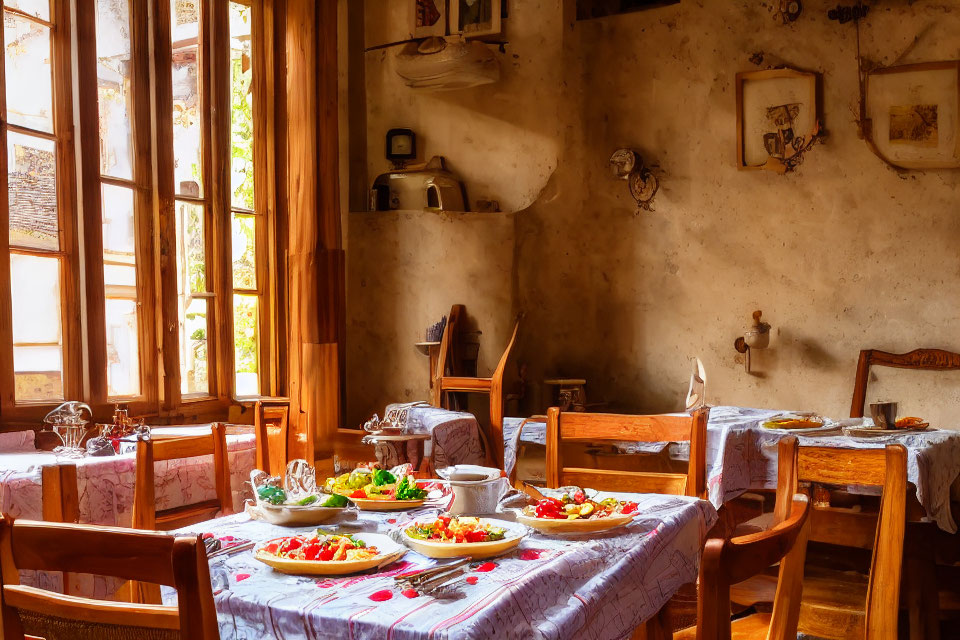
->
[[0, 0, 82, 424]]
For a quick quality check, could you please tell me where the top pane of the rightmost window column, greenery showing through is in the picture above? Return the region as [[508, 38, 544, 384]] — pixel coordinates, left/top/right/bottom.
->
[[230, 2, 254, 211]]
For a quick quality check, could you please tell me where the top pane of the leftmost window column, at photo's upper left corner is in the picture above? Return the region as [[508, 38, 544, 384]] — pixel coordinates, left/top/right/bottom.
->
[[3, 12, 53, 133]]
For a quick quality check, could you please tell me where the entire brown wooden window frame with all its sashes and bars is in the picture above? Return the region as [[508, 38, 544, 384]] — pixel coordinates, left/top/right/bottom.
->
[[0, 0, 286, 430]]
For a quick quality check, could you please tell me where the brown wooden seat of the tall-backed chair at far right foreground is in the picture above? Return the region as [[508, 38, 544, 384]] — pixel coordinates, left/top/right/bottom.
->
[[798, 565, 868, 640]]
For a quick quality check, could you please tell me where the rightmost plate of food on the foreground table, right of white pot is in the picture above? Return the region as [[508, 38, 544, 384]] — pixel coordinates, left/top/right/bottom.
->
[[517, 489, 637, 535]]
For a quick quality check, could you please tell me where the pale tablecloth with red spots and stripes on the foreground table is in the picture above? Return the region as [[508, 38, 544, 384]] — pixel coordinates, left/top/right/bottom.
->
[[165, 494, 717, 640]]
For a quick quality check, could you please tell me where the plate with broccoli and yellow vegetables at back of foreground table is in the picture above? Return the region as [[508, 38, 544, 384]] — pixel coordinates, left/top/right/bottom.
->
[[324, 468, 427, 511]]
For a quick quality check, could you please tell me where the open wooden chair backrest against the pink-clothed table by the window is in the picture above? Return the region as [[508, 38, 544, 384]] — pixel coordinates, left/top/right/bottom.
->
[[133, 423, 233, 530]]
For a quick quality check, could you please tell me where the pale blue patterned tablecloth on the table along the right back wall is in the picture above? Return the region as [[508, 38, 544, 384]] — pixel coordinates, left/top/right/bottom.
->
[[504, 406, 960, 533]]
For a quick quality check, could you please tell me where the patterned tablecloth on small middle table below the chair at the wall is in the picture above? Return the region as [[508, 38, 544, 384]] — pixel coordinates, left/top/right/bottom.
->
[[387, 404, 486, 469]]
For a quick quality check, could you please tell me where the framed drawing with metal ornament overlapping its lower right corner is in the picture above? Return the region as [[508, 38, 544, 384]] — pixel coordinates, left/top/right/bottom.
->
[[737, 69, 822, 173]]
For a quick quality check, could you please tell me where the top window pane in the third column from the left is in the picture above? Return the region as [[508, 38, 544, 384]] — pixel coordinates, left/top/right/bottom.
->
[[170, 0, 203, 197]]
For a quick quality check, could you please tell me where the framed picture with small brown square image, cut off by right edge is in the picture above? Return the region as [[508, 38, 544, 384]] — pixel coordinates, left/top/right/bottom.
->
[[863, 61, 960, 169]]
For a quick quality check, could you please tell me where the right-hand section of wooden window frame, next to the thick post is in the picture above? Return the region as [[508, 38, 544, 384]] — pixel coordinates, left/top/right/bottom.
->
[[153, 0, 280, 416]]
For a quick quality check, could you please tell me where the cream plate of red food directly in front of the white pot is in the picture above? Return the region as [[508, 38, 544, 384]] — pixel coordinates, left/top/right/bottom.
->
[[402, 514, 527, 559]]
